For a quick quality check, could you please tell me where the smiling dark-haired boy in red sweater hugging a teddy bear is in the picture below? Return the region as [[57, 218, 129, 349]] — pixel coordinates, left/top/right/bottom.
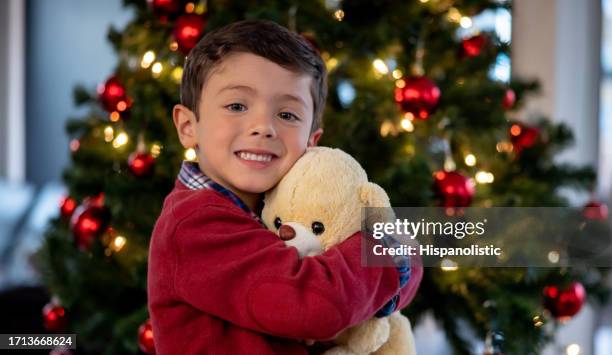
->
[[148, 21, 422, 355]]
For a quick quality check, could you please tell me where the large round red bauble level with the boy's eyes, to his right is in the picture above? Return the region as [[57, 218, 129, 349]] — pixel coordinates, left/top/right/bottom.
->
[[395, 76, 440, 120]]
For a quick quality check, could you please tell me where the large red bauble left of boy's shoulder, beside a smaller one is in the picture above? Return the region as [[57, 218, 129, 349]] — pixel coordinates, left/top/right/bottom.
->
[[70, 194, 110, 250]]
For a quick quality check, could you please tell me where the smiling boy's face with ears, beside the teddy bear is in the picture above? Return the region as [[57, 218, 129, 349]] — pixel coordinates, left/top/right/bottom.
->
[[174, 53, 322, 203]]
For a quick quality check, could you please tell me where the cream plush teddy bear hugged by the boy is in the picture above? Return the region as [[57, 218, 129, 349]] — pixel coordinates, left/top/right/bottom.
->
[[262, 147, 416, 355]]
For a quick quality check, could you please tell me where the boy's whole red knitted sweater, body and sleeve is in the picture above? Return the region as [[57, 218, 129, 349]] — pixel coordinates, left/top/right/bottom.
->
[[147, 180, 423, 355]]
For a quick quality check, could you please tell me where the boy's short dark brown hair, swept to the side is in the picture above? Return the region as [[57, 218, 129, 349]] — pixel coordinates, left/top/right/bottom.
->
[[181, 20, 327, 132]]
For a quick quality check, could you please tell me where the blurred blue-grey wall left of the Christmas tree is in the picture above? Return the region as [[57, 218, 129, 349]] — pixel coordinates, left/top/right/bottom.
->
[[26, 0, 131, 185]]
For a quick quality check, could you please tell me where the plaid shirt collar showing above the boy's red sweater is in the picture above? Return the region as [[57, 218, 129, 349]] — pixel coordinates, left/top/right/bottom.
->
[[177, 161, 265, 227]]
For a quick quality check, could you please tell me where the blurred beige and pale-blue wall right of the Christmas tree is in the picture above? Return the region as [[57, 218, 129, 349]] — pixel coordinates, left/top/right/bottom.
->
[[512, 0, 607, 200]]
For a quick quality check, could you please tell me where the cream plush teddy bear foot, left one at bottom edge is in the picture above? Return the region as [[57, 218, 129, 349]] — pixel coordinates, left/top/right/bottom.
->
[[347, 318, 391, 354]]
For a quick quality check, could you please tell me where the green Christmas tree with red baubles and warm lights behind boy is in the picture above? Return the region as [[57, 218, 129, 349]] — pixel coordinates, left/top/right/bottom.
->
[[38, 0, 607, 354]]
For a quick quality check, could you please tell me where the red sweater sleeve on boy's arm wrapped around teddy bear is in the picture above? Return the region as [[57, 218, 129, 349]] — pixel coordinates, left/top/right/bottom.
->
[[174, 205, 399, 340]]
